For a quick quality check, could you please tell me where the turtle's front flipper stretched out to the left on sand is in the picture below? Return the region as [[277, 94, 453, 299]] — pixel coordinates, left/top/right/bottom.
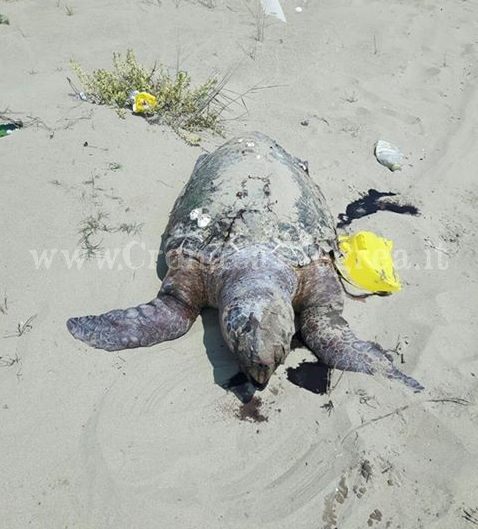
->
[[67, 293, 199, 351]]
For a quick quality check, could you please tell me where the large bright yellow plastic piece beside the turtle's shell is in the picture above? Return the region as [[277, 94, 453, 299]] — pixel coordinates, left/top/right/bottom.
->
[[339, 231, 402, 292]]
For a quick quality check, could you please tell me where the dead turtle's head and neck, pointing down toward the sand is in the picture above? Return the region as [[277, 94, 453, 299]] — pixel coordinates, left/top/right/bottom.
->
[[219, 248, 296, 389]]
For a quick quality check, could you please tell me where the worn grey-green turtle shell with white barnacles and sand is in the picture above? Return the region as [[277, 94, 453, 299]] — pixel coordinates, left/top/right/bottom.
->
[[164, 132, 337, 266]]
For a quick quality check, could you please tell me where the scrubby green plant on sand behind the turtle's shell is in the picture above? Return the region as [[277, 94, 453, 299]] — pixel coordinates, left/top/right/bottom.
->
[[71, 50, 227, 134]]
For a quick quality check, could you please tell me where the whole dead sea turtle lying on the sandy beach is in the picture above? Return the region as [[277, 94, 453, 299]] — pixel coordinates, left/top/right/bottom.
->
[[67, 132, 422, 390]]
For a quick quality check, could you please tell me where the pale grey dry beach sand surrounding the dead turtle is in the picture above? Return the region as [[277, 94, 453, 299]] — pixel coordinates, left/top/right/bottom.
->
[[0, 0, 478, 529]]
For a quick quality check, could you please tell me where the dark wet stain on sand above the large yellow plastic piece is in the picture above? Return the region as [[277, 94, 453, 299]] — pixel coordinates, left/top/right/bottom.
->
[[337, 189, 420, 228]]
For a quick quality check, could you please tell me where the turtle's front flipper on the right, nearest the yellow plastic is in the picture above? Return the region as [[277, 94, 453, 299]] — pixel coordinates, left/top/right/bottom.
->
[[300, 306, 424, 391]]
